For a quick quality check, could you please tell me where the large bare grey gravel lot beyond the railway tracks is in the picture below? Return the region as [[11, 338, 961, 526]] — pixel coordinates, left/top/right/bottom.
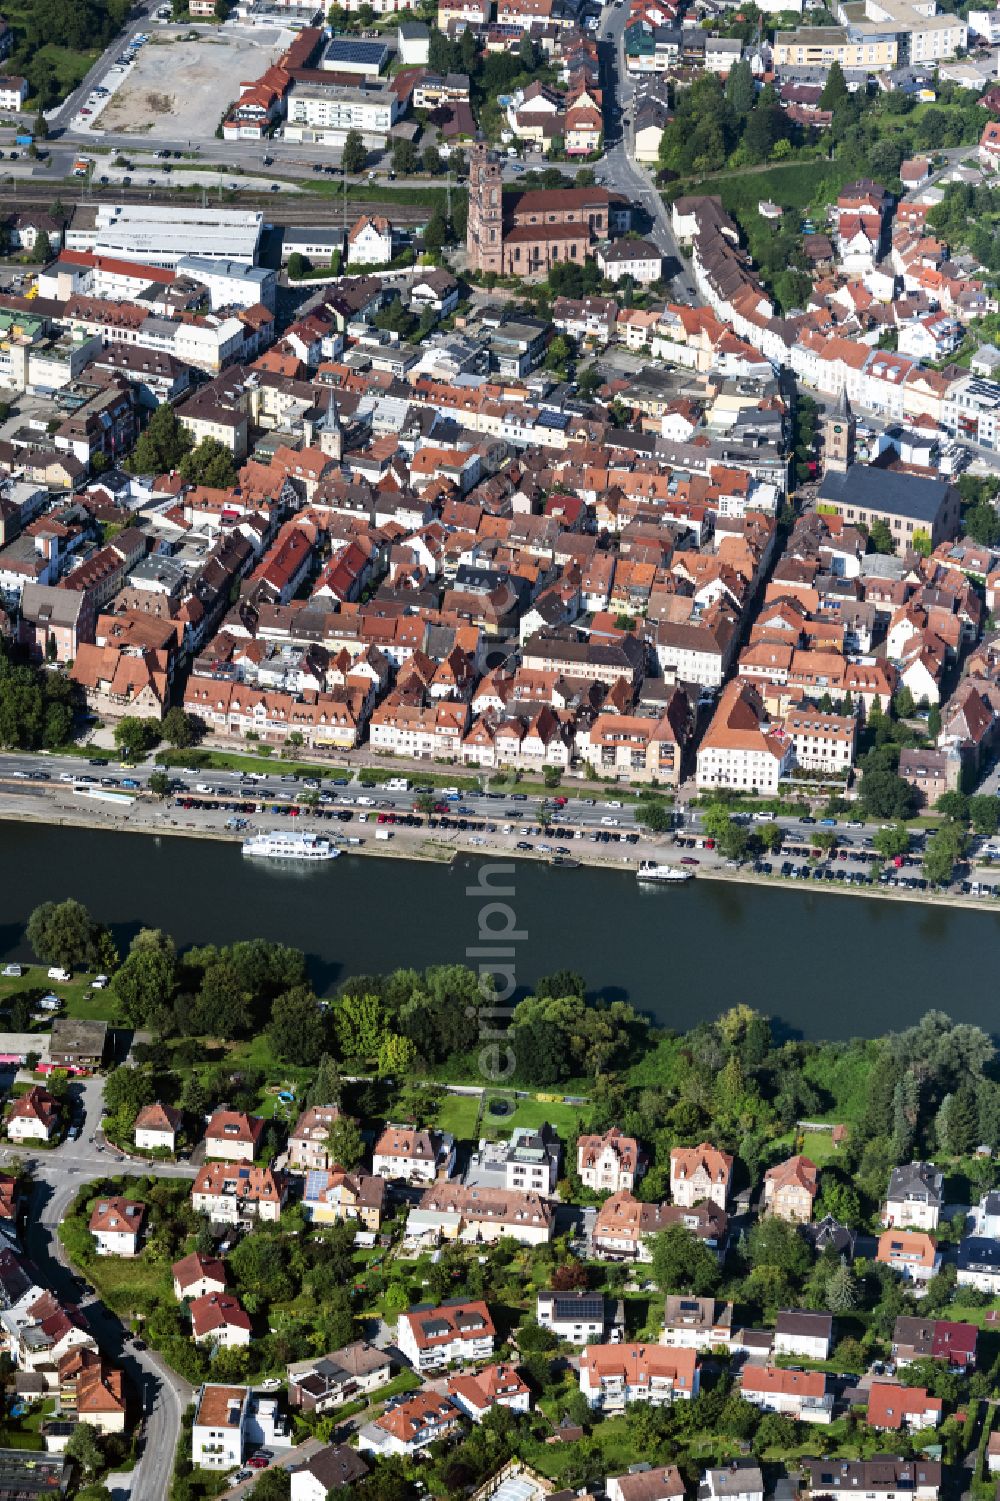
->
[[95, 27, 288, 141]]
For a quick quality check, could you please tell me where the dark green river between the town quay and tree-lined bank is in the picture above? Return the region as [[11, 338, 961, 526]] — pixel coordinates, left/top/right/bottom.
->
[[0, 823, 1000, 1037]]
